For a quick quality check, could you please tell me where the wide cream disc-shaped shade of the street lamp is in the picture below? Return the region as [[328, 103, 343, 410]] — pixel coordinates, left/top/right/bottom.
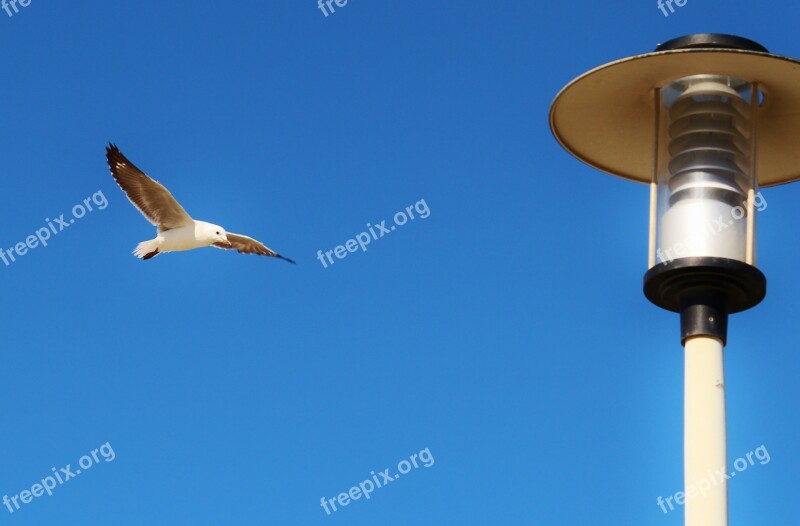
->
[[550, 41, 800, 188]]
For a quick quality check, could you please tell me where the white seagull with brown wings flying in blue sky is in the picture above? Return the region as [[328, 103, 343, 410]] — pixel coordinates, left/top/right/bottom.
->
[[106, 143, 294, 263]]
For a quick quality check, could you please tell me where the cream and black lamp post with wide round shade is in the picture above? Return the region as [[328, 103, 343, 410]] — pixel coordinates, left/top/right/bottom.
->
[[550, 34, 800, 526]]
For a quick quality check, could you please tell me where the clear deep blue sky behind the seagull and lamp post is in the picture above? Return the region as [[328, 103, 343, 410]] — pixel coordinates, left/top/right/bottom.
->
[[0, 0, 800, 526]]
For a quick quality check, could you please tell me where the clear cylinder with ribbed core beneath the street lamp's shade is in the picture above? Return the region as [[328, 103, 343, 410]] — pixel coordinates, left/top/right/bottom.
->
[[651, 75, 760, 265]]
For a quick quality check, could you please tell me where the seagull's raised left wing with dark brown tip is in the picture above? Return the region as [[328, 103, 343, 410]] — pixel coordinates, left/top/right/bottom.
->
[[106, 144, 193, 232]]
